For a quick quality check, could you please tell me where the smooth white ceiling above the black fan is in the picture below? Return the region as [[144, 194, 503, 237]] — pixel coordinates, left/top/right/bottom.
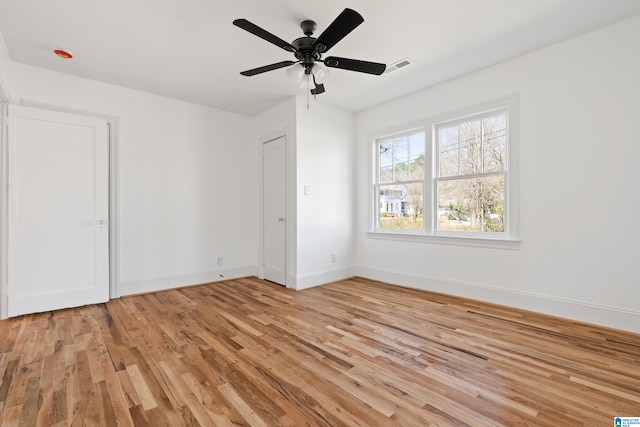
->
[[0, 0, 640, 115]]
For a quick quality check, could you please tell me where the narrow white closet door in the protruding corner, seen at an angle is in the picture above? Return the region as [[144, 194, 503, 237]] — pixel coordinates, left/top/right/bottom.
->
[[262, 137, 287, 286]]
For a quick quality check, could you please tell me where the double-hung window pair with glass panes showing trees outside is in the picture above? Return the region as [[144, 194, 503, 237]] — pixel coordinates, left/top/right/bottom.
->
[[373, 98, 517, 244]]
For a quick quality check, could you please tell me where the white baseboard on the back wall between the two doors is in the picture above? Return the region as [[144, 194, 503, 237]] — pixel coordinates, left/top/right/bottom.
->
[[118, 265, 257, 296]]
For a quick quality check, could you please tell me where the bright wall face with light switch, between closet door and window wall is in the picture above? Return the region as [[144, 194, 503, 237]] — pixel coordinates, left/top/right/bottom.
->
[[296, 97, 355, 289]]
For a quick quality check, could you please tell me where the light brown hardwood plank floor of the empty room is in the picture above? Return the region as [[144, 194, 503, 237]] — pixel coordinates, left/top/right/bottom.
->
[[0, 278, 640, 427]]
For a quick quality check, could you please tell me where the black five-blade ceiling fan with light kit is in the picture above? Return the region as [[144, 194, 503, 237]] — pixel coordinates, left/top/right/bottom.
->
[[233, 8, 386, 95]]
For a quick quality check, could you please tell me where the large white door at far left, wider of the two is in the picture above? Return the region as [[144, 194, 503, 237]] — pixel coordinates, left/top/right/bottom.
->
[[8, 105, 109, 316]]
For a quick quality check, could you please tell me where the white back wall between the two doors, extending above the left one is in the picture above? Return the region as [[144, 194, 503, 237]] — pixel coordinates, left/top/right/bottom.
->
[[5, 63, 258, 295]]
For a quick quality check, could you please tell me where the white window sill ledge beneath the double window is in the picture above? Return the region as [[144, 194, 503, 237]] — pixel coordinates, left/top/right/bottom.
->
[[366, 231, 522, 250]]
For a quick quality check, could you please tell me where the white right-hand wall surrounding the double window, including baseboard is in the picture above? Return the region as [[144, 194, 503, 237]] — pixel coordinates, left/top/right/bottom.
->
[[357, 17, 640, 332]]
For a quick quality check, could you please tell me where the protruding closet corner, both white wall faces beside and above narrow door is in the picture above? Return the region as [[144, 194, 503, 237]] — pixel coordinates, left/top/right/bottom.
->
[[254, 97, 355, 290]]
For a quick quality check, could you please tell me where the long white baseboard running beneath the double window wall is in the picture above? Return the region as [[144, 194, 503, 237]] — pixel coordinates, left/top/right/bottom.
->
[[355, 266, 640, 333]]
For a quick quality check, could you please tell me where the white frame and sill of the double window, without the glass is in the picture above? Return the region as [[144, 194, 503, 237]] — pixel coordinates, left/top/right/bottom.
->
[[367, 95, 520, 249]]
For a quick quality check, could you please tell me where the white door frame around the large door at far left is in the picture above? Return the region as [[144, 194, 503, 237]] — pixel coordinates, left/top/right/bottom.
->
[[0, 102, 120, 320]]
